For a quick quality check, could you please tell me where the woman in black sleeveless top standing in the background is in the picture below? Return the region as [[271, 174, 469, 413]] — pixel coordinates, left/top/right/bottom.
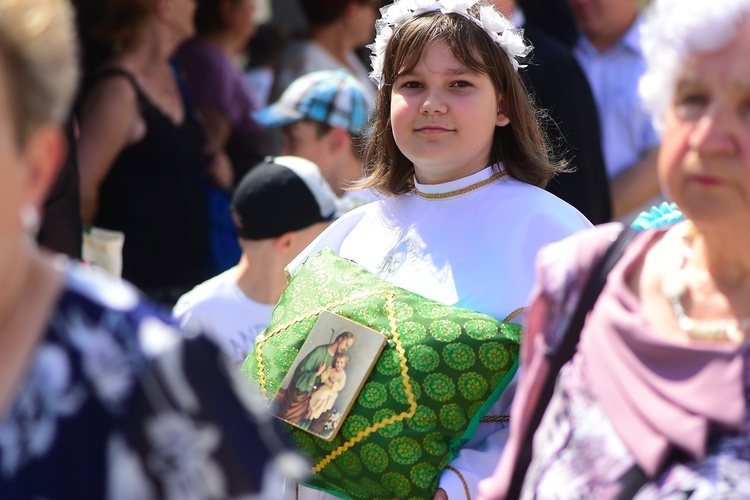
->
[[78, 0, 212, 304]]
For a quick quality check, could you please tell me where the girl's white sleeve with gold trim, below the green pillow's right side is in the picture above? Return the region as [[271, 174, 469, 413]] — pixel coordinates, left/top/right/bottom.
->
[[440, 369, 520, 500]]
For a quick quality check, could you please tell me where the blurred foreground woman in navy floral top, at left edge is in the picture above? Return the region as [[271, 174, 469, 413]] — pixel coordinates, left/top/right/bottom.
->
[[0, 0, 306, 499]]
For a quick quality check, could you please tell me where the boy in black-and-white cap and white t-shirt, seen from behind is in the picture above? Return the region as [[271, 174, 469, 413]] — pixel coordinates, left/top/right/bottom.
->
[[172, 156, 338, 364]]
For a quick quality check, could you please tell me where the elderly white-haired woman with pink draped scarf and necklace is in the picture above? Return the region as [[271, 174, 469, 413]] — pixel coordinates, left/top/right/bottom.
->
[[480, 0, 750, 499]]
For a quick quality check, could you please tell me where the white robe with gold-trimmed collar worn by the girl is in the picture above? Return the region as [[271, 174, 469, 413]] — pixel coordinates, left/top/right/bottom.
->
[[285, 167, 591, 499]]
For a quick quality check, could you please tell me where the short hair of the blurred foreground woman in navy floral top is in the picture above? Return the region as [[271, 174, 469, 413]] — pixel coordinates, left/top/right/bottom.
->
[[0, 0, 78, 144]]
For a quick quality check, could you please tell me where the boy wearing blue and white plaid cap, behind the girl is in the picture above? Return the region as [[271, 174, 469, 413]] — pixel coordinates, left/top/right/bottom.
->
[[253, 70, 373, 208]]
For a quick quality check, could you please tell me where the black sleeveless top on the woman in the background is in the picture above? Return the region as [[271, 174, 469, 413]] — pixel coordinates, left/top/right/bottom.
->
[[83, 67, 208, 302]]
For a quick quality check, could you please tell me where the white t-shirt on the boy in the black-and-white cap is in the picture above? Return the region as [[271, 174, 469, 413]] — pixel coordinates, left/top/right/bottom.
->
[[172, 267, 275, 365]]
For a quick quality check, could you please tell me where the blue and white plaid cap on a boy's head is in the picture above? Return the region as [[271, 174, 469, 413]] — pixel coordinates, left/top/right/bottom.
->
[[253, 69, 368, 135]]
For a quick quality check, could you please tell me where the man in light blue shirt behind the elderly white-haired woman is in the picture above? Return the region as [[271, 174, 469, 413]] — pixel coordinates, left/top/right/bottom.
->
[[568, 0, 660, 219]]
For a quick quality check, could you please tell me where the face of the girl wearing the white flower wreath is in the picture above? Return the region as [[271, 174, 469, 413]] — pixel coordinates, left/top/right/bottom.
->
[[391, 41, 509, 184]]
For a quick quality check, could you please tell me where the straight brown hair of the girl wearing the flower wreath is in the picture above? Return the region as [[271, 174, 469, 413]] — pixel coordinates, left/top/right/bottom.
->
[[359, 7, 564, 195]]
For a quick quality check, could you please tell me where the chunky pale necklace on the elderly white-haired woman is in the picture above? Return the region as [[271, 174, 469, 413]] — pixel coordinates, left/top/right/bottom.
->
[[661, 222, 750, 343]]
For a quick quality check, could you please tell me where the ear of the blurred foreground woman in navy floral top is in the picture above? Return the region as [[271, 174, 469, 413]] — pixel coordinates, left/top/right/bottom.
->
[[24, 124, 68, 209]]
